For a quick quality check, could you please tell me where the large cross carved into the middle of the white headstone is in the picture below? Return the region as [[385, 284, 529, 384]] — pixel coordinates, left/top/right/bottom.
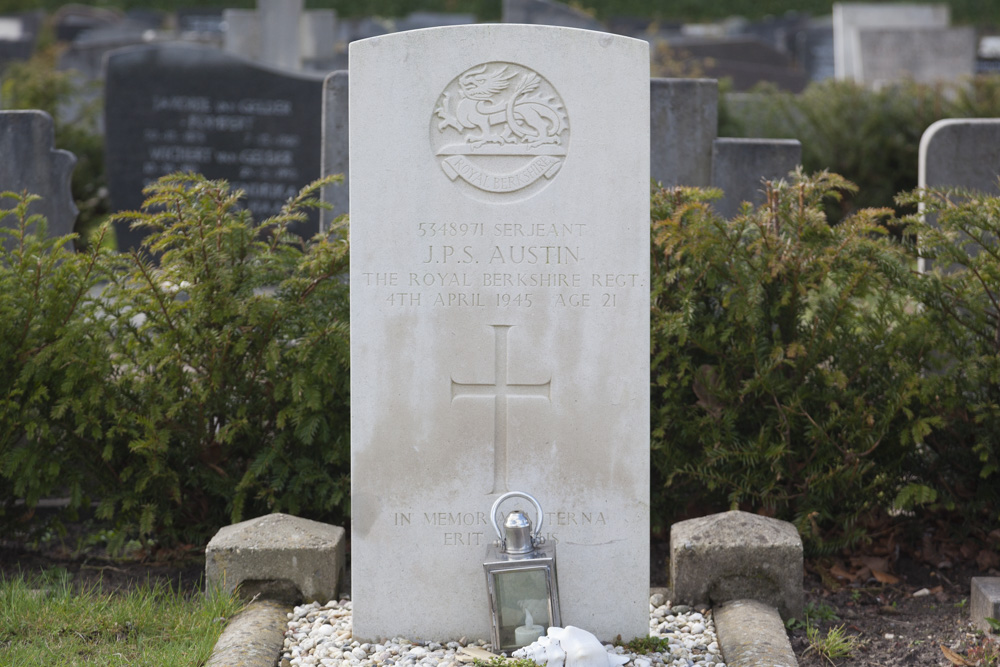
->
[[451, 324, 552, 494]]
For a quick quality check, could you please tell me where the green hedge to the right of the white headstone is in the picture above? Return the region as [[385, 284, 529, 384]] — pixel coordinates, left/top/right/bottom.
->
[[651, 172, 1000, 552]]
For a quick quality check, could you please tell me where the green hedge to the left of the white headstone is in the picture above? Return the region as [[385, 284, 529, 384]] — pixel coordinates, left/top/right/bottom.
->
[[0, 175, 350, 542]]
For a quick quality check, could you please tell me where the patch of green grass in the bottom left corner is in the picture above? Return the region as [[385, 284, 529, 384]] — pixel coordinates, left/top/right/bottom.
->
[[0, 570, 242, 667]]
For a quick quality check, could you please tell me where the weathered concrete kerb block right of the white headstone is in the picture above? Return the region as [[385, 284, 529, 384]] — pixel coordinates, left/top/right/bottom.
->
[[670, 511, 804, 620]]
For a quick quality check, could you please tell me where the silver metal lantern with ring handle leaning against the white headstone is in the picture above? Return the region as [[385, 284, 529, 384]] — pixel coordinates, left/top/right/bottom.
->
[[483, 491, 562, 652]]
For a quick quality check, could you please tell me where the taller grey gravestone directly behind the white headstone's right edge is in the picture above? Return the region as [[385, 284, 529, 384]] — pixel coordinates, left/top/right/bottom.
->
[[649, 79, 719, 187]]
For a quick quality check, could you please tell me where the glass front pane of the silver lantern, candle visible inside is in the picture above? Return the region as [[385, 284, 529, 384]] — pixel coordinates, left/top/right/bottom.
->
[[493, 567, 552, 650]]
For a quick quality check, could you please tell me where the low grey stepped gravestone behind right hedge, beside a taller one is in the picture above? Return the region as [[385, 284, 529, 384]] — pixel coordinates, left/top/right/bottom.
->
[[712, 138, 802, 218]]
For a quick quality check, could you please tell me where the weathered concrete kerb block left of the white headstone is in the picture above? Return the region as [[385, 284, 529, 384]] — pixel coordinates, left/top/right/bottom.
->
[[205, 514, 346, 604]]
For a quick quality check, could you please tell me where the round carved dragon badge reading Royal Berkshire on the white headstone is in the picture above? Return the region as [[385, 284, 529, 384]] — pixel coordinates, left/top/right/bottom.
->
[[431, 62, 569, 195]]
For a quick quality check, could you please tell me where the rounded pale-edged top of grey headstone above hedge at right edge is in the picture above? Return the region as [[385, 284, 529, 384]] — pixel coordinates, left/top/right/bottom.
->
[[917, 118, 1000, 193]]
